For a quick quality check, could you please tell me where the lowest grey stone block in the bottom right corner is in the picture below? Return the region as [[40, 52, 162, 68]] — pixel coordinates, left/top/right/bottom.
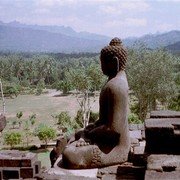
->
[[145, 170, 180, 180]]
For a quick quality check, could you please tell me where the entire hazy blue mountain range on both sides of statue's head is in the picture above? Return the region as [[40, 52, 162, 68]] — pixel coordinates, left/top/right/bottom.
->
[[0, 21, 180, 53]]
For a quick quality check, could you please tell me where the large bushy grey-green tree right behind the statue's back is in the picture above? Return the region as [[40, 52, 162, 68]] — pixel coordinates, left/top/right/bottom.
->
[[127, 45, 175, 120]]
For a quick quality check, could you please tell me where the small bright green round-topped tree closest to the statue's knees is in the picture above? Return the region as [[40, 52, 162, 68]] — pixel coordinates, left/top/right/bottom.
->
[[35, 124, 56, 148]]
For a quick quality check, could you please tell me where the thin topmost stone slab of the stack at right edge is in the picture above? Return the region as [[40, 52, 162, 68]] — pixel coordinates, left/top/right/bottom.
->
[[150, 110, 180, 118]]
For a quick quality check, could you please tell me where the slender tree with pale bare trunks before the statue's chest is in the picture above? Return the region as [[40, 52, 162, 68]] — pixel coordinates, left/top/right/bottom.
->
[[69, 63, 105, 127]]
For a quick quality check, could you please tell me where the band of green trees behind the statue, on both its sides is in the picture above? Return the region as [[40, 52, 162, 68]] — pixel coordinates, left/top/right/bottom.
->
[[0, 44, 180, 124]]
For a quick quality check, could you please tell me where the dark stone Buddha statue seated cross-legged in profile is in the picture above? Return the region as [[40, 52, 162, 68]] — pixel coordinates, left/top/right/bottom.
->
[[62, 38, 130, 169]]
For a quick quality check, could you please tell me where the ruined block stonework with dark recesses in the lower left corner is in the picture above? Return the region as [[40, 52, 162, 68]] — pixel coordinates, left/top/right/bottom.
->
[[0, 150, 41, 179]]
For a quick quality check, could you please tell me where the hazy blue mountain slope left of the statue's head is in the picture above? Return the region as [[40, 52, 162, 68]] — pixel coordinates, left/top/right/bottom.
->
[[0, 22, 110, 53]]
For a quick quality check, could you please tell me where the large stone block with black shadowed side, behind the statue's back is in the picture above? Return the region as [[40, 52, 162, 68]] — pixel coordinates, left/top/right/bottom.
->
[[145, 118, 180, 154]]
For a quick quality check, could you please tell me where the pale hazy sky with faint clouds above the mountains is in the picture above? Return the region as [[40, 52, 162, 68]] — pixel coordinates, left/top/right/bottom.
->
[[0, 0, 180, 38]]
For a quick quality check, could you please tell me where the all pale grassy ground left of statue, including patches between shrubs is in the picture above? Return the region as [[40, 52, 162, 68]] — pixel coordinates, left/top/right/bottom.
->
[[0, 90, 99, 168]]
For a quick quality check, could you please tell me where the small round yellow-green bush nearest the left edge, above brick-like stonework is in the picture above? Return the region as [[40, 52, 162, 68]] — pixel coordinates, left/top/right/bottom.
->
[[4, 132, 22, 149]]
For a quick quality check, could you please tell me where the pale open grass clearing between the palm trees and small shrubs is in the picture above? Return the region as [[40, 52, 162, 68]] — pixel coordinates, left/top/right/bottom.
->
[[2, 90, 99, 125]]
